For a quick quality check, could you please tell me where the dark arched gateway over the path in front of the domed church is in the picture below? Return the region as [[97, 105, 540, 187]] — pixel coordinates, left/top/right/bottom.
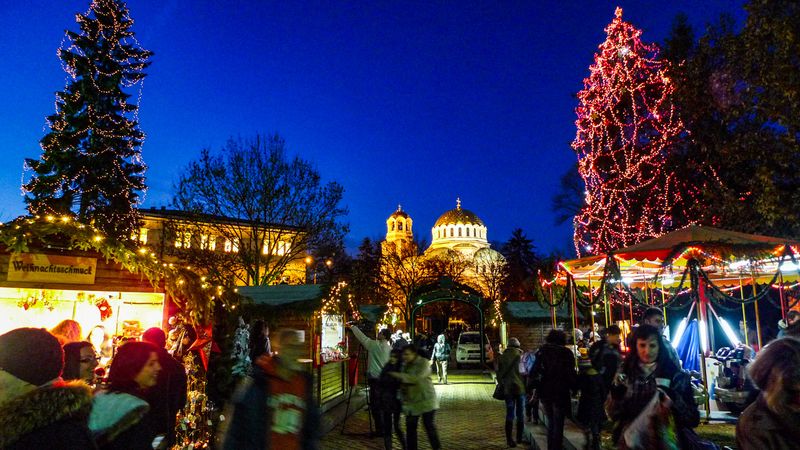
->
[[409, 277, 486, 367]]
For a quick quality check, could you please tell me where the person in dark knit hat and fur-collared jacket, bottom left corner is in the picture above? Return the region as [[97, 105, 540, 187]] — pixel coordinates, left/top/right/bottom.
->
[[0, 328, 96, 450]]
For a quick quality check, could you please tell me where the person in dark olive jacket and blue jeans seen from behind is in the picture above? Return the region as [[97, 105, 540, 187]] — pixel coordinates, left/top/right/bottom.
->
[[497, 337, 525, 447]]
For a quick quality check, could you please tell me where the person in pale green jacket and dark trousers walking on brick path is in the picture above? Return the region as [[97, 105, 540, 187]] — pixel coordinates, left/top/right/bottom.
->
[[389, 345, 442, 450]]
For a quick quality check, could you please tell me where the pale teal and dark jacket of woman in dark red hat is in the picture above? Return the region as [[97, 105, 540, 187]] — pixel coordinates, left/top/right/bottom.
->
[[89, 391, 156, 450]]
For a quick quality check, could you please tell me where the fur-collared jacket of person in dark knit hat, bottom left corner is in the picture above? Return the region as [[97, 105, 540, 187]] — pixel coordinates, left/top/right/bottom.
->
[[0, 371, 96, 450]]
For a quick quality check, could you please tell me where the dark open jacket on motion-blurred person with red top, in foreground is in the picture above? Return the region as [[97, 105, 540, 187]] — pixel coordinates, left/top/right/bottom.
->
[[218, 356, 320, 450]]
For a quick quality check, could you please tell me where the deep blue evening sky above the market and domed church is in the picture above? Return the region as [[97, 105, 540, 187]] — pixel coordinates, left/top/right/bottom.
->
[[0, 0, 742, 251]]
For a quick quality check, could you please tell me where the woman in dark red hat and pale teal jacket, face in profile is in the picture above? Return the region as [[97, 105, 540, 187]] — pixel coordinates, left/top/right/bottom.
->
[[89, 341, 161, 450]]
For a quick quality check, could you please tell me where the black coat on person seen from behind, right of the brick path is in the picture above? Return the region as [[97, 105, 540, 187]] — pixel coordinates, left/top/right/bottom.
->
[[531, 344, 577, 408]]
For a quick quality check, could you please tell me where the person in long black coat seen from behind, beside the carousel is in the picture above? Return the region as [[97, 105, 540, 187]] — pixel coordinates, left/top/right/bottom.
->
[[533, 329, 576, 450]]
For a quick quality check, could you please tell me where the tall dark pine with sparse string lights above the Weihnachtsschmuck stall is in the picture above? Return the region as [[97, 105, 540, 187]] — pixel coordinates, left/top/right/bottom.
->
[[23, 0, 152, 238]]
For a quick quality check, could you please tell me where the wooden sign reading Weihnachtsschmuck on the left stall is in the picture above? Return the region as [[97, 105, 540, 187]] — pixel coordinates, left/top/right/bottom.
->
[[6, 253, 97, 284]]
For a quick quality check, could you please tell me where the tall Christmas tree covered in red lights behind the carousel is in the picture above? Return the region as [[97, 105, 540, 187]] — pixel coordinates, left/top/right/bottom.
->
[[572, 8, 684, 254]]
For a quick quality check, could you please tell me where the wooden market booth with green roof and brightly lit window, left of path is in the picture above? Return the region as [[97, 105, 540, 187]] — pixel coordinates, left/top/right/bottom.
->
[[239, 284, 350, 412]]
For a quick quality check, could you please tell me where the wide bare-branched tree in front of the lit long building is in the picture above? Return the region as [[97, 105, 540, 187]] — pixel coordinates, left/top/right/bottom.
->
[[173, 135, 347, 285]]
